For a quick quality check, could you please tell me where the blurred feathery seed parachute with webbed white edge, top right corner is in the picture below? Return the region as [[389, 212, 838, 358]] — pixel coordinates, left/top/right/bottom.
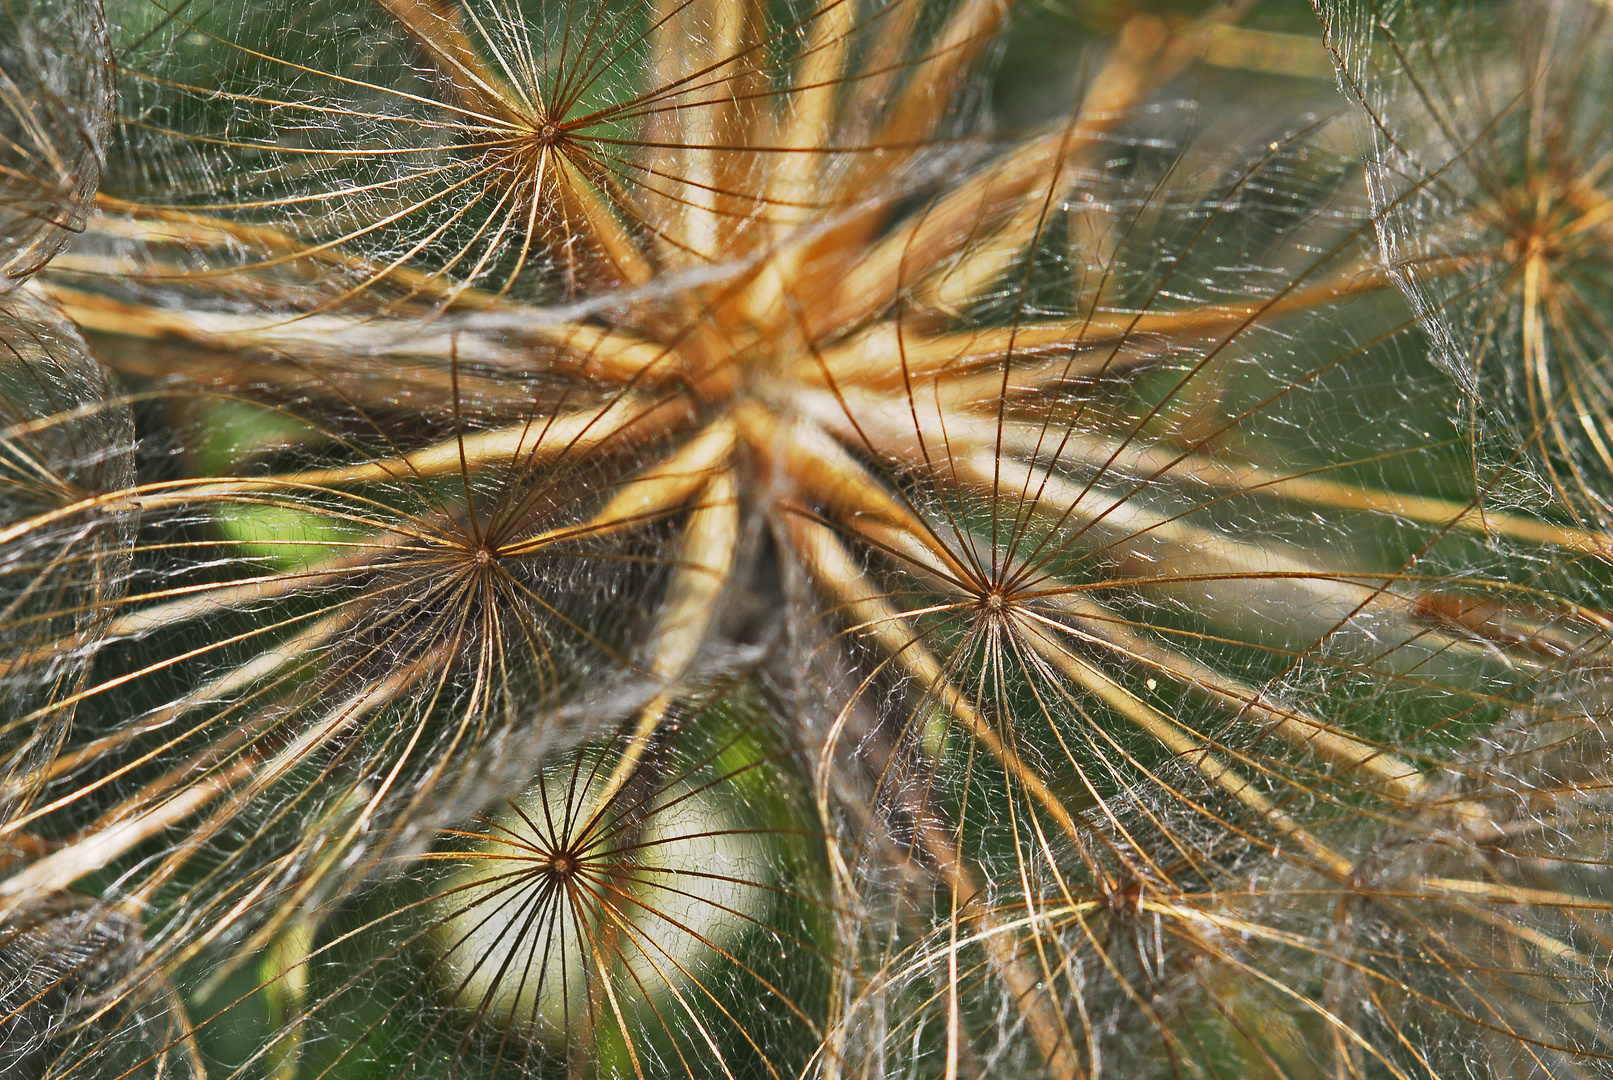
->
[[1323, 0, 1613, 538]]
